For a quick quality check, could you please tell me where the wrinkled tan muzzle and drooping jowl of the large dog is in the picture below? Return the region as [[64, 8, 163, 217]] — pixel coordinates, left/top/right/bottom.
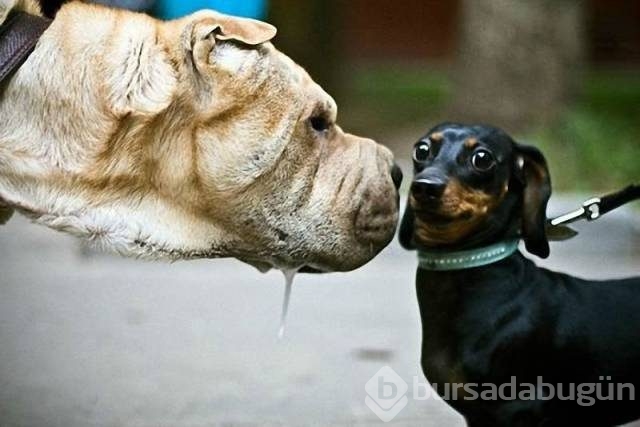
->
[[237, 136, 402, 272]]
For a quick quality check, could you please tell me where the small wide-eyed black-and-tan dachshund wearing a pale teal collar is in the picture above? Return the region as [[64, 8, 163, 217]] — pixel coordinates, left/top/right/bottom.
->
[[400, 123, 640, 427]]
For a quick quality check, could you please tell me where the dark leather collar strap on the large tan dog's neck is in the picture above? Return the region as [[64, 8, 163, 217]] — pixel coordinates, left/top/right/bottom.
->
[[0, 12, 51, 83]]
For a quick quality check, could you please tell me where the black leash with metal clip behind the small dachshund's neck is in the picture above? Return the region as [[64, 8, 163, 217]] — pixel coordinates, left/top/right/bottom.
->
[[547, 184, 640, 240]]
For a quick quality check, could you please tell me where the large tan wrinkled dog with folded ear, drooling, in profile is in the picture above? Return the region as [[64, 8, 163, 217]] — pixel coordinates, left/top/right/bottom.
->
[[0, 0, 400, 271]]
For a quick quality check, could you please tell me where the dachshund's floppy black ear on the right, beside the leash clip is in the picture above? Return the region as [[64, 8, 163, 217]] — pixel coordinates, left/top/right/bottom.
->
[[514, 144, 551, 258]]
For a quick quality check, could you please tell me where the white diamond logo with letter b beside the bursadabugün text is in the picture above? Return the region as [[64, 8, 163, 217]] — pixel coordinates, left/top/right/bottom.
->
[[364, 366, 409, 423]]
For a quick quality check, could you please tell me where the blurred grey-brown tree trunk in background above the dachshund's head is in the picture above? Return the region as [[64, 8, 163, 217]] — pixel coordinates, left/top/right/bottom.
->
[[453, 0, 586, 130]]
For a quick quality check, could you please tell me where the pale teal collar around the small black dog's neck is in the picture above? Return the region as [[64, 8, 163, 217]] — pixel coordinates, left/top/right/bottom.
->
[[418, 239, 520, 271]]
